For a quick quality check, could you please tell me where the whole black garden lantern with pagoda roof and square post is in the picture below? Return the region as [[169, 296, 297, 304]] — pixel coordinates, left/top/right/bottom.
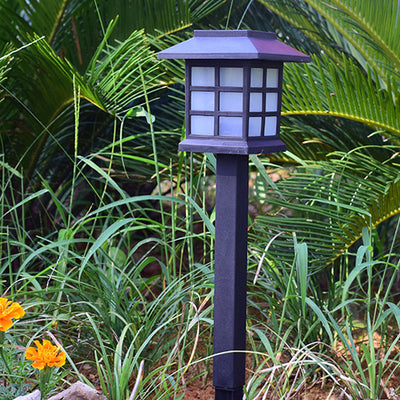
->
[[158, 30, 310, 400]]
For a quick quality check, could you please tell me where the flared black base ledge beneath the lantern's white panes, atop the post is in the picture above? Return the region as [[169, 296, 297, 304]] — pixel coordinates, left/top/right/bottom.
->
[[179, 137, 286, 154]]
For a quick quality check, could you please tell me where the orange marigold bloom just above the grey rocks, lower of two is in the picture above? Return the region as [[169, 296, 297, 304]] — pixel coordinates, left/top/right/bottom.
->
[[25, 340, 66, 369]]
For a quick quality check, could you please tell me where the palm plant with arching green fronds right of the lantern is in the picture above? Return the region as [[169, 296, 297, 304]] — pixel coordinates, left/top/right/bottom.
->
[[219, 0, 400, 269]]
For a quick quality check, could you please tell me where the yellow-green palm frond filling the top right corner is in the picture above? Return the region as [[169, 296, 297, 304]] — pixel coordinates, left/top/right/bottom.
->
[[258, 0, 400, 78]]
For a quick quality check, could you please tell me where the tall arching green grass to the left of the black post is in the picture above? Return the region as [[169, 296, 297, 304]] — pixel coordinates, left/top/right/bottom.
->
[[0, 94, 217, 399]]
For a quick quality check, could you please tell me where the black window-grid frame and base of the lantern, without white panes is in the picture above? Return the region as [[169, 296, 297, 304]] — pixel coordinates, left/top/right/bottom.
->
[[179, 60, 286, 154]]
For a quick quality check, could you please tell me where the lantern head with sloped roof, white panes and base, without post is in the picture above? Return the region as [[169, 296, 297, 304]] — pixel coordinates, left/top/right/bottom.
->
[[159, 30, 310, 155]]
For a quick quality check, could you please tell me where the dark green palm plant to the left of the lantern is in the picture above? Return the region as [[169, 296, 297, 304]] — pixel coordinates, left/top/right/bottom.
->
[[0, 0, 227, 267]]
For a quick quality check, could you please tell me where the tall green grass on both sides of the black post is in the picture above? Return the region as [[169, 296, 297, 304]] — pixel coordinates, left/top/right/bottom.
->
[[0, 38, 400, 400]]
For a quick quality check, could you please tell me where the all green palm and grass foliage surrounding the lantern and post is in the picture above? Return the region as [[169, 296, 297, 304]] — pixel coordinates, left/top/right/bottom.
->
[[0, 0, 400, 400]]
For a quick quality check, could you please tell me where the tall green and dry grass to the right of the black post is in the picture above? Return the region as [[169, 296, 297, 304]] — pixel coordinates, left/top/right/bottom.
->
[[247, 220, 400, 399]]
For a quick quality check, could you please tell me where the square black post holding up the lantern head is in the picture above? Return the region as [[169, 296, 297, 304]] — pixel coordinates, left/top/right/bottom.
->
[[213, 154, 249, 400]]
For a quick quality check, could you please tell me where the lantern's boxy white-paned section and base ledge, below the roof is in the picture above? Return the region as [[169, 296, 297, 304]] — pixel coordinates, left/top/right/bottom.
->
[[184, 60, 285, 154]]
